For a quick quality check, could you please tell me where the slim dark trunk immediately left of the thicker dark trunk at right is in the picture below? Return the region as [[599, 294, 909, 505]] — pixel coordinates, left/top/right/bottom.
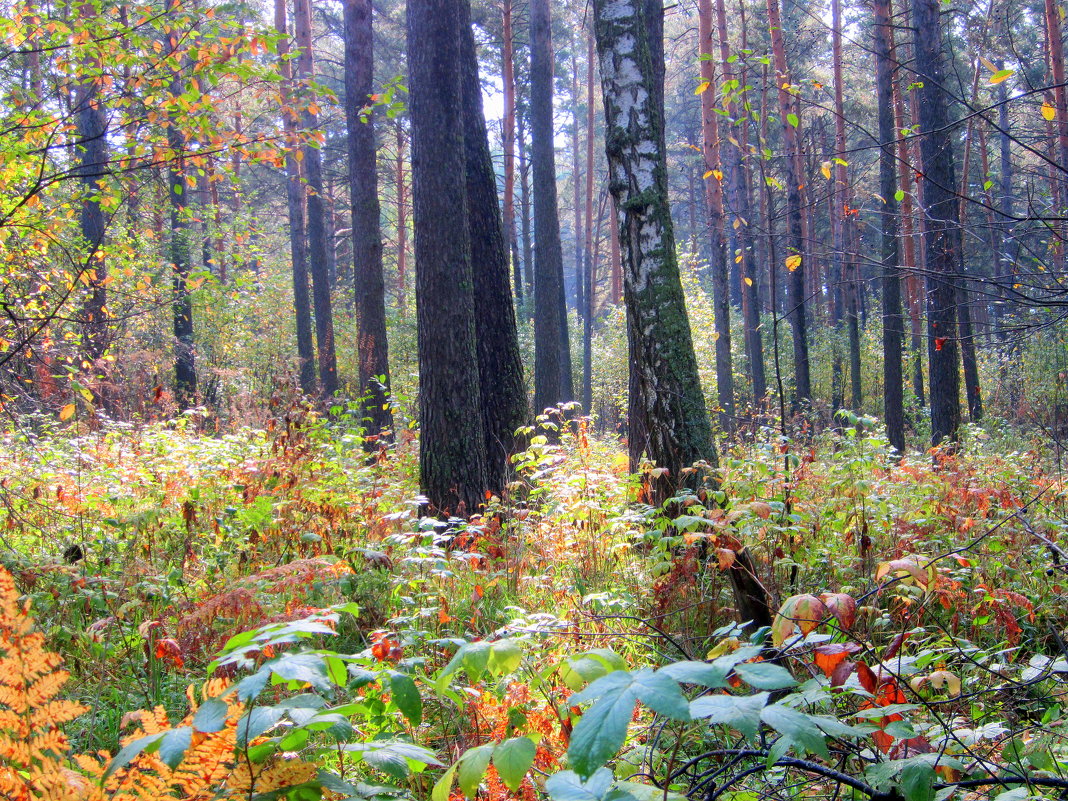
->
[[871, 0, 905, 454]]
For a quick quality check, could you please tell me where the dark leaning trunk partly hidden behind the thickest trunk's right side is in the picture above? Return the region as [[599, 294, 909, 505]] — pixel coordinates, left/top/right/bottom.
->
[[459, 0, 527, 492]]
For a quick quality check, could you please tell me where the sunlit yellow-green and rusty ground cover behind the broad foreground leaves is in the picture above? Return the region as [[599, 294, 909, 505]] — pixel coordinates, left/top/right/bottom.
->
[[0, 408, 1068, 798]]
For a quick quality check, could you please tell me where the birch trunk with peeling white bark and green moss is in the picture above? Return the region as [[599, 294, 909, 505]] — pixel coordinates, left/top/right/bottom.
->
[[594, 0, 717, 500]]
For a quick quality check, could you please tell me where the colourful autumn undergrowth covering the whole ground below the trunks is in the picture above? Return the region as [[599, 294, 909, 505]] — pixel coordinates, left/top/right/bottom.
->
[[0, 405, 1068, 801]]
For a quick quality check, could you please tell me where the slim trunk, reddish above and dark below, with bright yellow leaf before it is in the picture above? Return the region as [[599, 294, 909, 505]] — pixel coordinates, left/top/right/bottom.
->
[[767, 0, 812, 403]]
